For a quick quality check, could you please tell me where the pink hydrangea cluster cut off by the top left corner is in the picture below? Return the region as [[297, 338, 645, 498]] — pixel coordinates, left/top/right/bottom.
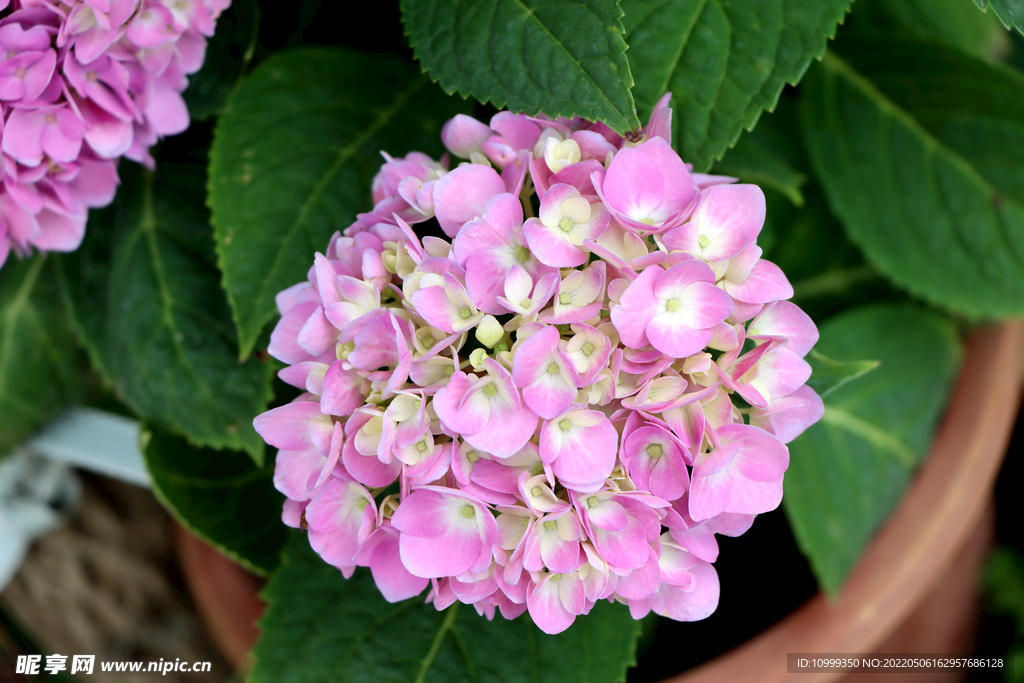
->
[[0, 0, 230, 266]]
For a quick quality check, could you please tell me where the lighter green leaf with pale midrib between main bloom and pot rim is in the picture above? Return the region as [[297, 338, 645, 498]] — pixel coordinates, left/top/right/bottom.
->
[[783, 305, 962, 594]]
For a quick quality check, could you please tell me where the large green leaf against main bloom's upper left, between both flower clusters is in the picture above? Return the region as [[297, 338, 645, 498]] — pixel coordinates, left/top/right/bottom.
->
[[209, 48, 468, 358]]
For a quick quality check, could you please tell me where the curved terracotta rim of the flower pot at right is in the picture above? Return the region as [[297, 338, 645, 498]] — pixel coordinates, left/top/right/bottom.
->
[[662, 321, 1024, 683]]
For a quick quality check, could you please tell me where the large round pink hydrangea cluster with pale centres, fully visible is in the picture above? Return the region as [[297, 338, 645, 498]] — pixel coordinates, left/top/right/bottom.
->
[[254, 96, 823, 633]]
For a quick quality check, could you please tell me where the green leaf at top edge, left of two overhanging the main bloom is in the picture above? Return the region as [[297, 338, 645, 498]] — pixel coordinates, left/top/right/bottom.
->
[[401, 0, 640, 133]]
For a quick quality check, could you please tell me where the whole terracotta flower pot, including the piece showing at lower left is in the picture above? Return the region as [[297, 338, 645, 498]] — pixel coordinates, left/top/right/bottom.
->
[[177, 322, 1024, 683]]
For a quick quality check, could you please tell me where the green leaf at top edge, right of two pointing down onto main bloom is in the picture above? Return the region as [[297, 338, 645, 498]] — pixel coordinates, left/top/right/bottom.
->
[[622, 0, 850, 171]]
